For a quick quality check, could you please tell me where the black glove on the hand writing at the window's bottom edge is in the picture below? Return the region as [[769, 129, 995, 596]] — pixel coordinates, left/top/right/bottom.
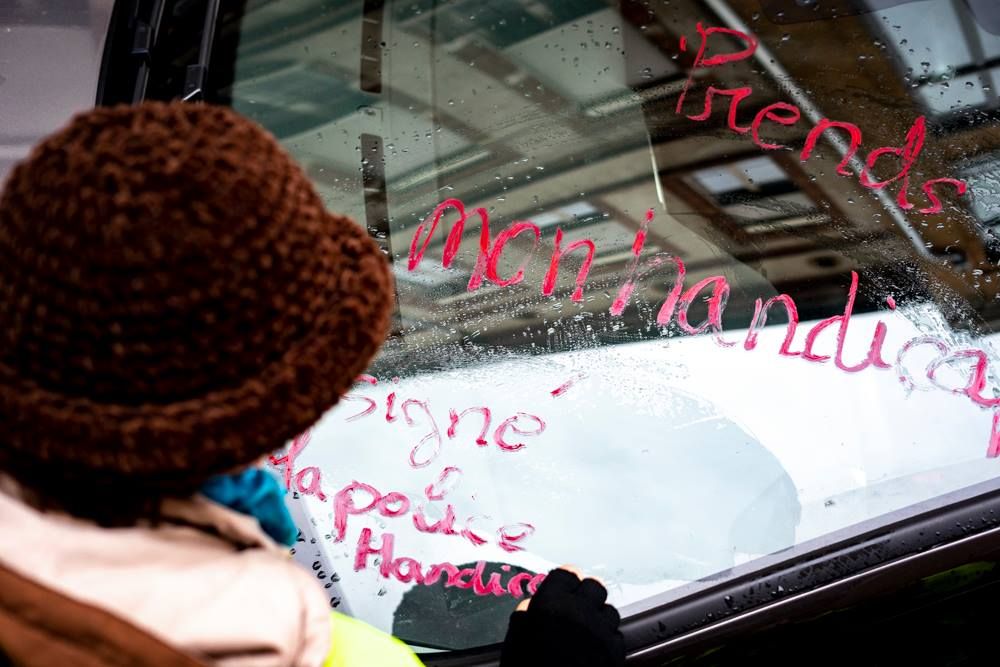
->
[[500, 569, 625, 667]]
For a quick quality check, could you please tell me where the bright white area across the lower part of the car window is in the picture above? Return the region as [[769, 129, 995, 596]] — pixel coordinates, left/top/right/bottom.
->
[[278, 307, 1000, 630]]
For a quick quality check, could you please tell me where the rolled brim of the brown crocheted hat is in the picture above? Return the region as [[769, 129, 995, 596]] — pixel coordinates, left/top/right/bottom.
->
[[0, 206, 391, 490]]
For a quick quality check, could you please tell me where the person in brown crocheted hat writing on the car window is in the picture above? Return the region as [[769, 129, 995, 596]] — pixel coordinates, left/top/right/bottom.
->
[[0, 103, 624, 667]]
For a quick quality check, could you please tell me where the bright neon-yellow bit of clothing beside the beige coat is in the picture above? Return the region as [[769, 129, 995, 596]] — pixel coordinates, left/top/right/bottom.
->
[[323, 611, 424, 667]]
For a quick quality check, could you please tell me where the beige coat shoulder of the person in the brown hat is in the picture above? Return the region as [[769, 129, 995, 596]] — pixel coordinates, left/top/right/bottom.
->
[[0, 480, 330, 667]]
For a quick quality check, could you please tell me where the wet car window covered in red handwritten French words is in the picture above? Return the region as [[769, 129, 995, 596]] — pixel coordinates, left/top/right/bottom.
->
[[211, 0, 1000, 649]]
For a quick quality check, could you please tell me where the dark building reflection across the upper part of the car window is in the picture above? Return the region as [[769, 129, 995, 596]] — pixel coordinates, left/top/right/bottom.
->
[[195, 0, 1000, 369]]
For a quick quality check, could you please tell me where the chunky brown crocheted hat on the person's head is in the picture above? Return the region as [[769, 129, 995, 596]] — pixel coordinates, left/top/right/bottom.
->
[[0, 102, 392, 494]]
